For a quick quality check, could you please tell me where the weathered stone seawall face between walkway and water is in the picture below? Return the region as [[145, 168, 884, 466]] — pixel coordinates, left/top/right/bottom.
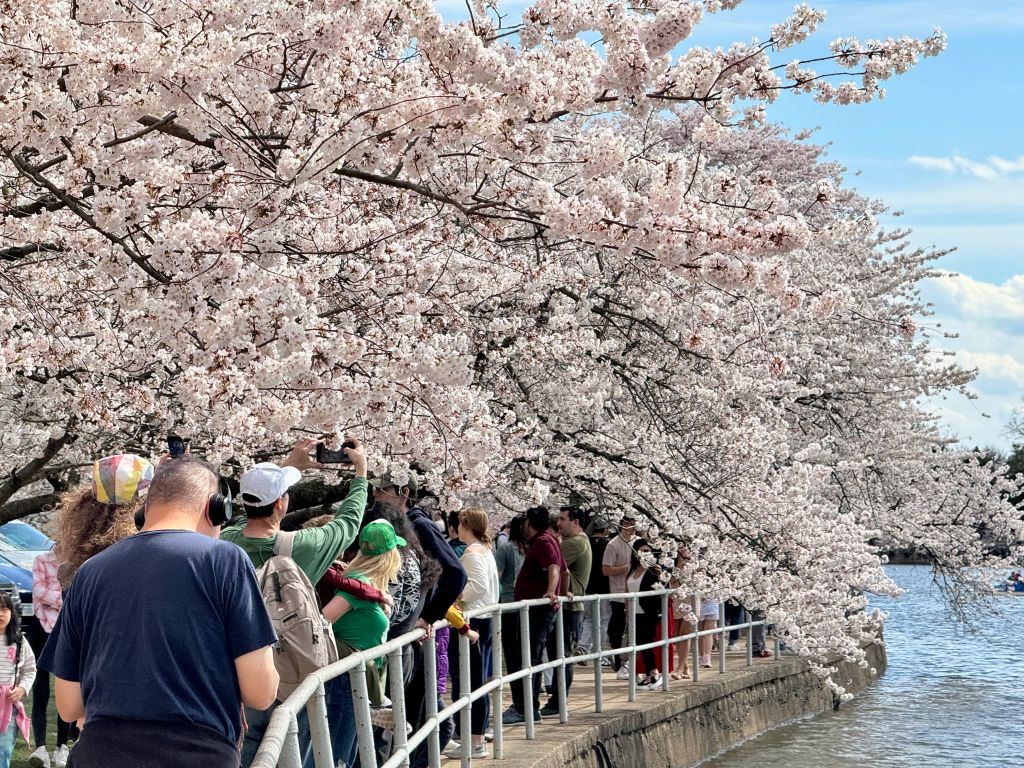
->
[[548, 645, 886, 768]]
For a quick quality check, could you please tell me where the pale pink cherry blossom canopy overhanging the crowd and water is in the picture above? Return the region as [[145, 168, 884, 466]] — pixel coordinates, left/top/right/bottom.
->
[[0, 0, 1021, 662]]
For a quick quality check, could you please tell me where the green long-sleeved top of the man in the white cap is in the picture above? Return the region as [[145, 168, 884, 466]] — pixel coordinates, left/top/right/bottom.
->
[[220, 477, 367, 585]]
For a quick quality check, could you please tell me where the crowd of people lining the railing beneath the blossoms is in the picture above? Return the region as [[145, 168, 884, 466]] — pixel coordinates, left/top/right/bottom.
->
[[0, 439, 763, 768]]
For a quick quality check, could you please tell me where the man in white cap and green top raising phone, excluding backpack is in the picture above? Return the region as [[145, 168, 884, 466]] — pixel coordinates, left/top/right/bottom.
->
[[220, 439, 367, 768]]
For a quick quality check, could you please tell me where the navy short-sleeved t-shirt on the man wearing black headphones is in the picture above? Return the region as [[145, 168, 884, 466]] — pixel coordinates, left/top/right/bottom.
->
[[39, 530, 276, 744]]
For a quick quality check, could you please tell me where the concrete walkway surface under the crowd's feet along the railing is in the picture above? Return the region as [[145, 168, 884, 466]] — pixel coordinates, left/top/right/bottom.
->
[[442, 651, 782, 768]]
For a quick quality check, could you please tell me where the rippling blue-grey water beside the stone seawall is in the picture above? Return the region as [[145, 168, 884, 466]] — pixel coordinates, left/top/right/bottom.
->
[[701, 566, 1024, 768]]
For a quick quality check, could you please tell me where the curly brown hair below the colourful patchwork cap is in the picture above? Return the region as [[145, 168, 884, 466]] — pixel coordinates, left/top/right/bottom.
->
[[53, 484, 143, 581]]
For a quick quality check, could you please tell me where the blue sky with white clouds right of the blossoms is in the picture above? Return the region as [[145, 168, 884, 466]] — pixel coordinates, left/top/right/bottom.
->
[[689, 0, 1024, 451]]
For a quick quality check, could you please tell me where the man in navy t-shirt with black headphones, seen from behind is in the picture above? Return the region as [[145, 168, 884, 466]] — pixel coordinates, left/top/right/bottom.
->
[[40, 456, 278, 768]]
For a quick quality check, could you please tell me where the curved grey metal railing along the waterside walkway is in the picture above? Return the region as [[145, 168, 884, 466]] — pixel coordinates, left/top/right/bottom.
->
[[252, 589, 780, 768]]
